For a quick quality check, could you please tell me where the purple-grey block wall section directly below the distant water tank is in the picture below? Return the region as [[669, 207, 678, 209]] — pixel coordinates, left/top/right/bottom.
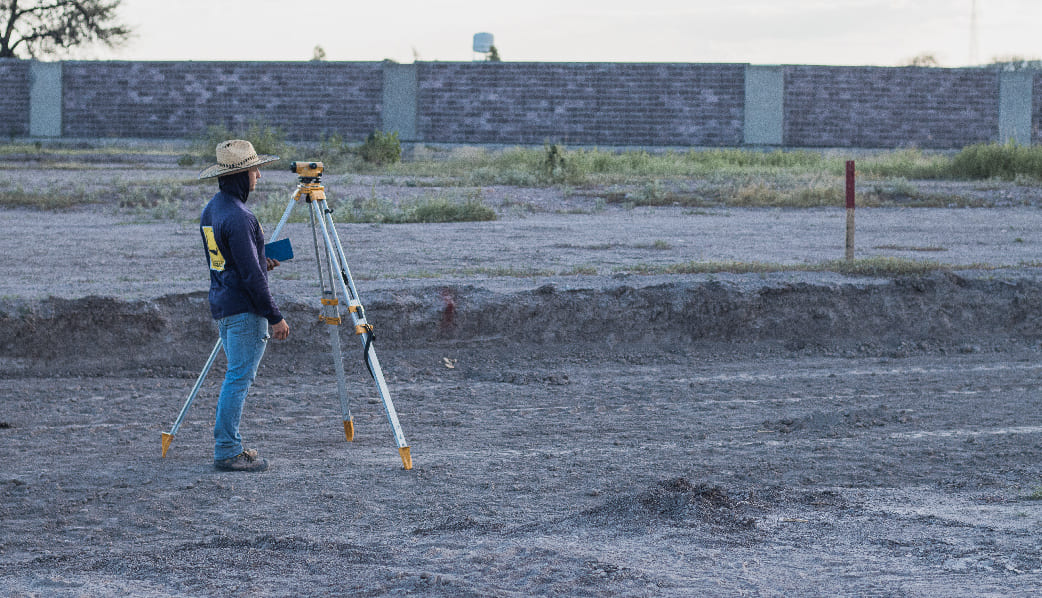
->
[[418, 63, 745, 146]]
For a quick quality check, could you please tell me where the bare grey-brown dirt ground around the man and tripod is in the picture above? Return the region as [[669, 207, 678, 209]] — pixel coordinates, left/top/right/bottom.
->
[[0, 161, 1042, 597]]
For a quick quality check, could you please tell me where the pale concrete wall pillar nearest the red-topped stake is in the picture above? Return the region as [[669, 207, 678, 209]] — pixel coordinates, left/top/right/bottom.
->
[[743, 65, 785, 146]]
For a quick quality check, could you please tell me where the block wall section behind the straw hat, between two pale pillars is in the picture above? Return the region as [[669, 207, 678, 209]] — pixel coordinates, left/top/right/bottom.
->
[[63, 61, 382, 140]]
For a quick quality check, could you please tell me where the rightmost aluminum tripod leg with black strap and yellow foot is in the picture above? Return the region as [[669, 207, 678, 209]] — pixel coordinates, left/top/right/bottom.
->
[[317, 198, 413, 469]]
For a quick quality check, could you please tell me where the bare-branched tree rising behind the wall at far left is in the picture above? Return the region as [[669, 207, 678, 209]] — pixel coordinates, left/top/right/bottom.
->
[[0, 0, 130, 58]]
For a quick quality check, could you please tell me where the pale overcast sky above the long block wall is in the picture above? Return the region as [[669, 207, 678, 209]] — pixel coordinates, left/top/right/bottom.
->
[[74, 0, 1042, 67]]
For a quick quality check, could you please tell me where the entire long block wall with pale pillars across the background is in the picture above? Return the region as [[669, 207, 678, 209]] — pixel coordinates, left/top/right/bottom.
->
[[8, 60, 1042, 149]]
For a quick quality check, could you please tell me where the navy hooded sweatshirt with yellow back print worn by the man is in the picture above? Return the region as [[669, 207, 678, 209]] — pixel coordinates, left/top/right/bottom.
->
[[199, 172, 282, 324]]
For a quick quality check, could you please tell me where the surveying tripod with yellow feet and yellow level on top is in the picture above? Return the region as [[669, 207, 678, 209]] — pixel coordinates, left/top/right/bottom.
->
[[163, 161, 413, 469]]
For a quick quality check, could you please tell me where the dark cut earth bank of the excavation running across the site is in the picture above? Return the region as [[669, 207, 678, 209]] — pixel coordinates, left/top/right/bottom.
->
[[0, 272, 1042, 376]]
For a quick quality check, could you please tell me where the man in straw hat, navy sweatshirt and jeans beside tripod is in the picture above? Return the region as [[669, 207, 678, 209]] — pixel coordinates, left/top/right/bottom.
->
[[199, 140, 290, 471]]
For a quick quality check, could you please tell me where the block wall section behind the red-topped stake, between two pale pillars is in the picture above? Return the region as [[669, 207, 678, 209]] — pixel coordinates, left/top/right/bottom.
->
[[783, 66, 999, 148]]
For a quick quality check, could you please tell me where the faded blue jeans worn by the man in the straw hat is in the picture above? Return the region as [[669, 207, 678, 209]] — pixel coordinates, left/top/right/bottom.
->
[[214, 314, 268, 460]]
